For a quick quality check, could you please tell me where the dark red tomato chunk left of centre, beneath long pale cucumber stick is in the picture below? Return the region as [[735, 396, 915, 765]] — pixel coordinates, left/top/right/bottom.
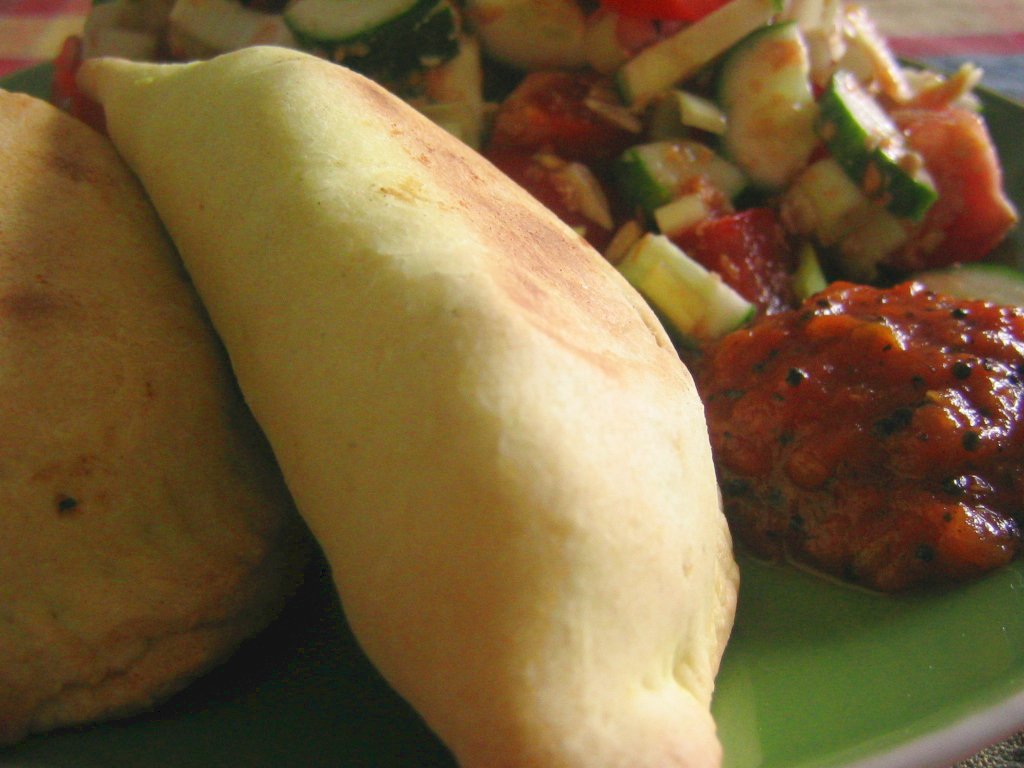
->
[[488, 72, 639, 164]]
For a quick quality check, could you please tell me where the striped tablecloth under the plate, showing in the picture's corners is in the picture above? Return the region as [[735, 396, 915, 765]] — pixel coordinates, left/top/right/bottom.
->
[[0, 0, 1024, 768]]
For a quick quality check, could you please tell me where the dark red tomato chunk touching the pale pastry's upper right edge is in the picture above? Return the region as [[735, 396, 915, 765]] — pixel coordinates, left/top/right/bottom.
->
[[486, 150, 612, 251]]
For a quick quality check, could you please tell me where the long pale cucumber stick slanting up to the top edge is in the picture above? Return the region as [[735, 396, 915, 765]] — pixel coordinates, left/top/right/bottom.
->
[[615, 0, 781, 105]]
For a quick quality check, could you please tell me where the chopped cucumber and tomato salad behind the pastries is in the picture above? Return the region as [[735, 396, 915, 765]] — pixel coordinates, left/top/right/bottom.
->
[[68, 0, 1018, 346]]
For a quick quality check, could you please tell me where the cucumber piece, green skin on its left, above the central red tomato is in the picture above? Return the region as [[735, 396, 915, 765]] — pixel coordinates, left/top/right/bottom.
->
[[615, 139, 746, 215]]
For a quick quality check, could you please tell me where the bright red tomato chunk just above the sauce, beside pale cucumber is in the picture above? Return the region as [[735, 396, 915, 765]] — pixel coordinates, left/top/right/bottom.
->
[[673, 208, 795, 313]]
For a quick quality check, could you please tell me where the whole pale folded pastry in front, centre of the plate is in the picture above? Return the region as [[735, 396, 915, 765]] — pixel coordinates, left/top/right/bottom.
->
[[80, 47, 737, 767]]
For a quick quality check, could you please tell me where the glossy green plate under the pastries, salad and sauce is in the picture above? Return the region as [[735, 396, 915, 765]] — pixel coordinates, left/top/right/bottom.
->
[[0, 67, 1024, 768]]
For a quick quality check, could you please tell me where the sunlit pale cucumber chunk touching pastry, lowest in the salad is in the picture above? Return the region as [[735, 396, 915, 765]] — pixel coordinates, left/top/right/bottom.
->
[[617, 232, 755, 342]]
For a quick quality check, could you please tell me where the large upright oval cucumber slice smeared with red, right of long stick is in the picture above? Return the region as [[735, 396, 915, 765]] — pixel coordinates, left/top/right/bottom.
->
[[718, 22, 818, 189]]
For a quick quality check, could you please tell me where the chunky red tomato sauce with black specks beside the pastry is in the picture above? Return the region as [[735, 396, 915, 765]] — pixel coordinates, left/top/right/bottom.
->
[[697, 283, 1024, 591]]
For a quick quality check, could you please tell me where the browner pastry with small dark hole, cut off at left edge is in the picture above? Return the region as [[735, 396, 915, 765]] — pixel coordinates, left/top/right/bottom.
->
[[0, 91, 307, 743]]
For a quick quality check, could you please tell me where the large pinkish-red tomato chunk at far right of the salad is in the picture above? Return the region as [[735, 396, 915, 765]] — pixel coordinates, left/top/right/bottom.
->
[[893, 108, 1017, 270]]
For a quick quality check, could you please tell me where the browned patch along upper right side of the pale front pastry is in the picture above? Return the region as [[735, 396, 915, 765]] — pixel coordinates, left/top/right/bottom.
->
[[334, 70, 688, 373]]
